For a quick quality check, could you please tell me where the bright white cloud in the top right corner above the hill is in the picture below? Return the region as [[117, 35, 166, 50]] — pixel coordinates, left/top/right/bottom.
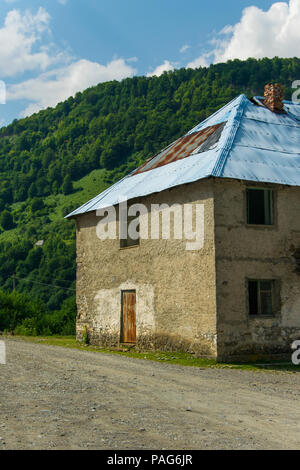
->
[[188, 0, 300, 67]]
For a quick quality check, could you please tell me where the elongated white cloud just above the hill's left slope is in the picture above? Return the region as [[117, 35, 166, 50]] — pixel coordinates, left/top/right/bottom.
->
[[7, 59, 136, 116]]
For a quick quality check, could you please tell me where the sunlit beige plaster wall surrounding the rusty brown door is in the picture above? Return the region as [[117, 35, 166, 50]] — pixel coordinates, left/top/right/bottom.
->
[[77, 180, 216, 355]]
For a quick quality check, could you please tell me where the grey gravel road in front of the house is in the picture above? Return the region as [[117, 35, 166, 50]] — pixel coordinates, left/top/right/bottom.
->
[[0, 339, 300, 450]]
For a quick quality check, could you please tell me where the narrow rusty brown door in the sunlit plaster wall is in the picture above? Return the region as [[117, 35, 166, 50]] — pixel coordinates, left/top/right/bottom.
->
[[121, 291, 136, 343]]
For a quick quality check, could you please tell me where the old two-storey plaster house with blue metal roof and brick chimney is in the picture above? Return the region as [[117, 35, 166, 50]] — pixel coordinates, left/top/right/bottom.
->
[[67, 84, 300, 360]]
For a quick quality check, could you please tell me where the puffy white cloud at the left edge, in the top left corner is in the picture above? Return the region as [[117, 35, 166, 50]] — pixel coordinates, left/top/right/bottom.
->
[[0, 8, 64, 78]]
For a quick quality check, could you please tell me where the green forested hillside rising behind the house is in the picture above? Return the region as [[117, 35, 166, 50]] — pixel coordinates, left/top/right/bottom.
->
[[0, 58, 300, 333]]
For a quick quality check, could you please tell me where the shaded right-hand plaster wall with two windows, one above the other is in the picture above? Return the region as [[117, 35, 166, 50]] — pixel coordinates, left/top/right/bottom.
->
[[215, 180, 300, 358]]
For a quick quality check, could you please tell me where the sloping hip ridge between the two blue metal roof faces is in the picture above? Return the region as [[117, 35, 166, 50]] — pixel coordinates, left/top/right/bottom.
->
[[212, 94, 249, 177]]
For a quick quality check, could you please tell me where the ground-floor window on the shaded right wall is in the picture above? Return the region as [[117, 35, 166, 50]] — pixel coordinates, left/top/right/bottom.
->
[[248, 280, 275, 316]]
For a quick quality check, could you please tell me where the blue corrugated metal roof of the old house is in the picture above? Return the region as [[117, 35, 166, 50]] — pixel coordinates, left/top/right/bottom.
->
[[67, 95, 300, 217]]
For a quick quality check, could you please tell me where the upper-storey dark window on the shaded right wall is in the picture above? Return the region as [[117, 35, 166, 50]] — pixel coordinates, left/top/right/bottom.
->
[[247, 189, 274, 225]]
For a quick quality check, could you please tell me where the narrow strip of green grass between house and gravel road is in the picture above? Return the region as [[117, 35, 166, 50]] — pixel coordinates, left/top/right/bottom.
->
[[7, 336, 300, 372]]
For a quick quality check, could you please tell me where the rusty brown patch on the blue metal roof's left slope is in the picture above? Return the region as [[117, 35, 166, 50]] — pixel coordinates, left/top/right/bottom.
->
[[133, 122, 226, 175]]
